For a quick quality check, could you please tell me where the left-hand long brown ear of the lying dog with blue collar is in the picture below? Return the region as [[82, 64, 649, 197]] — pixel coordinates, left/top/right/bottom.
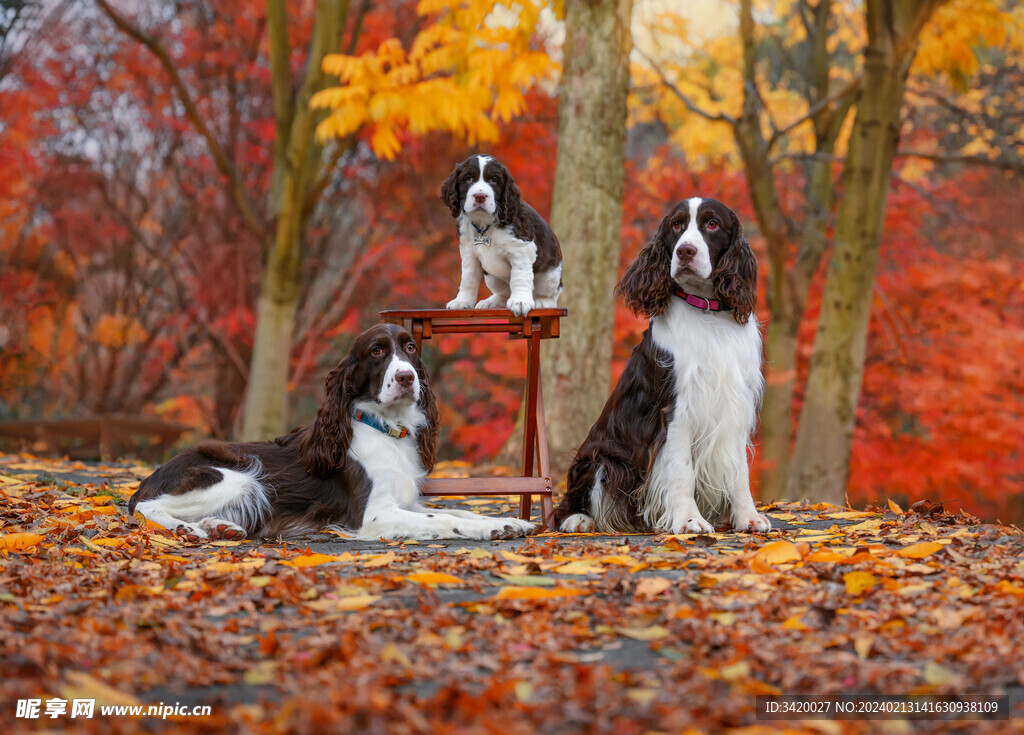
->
[[299, 354, 356, 478]]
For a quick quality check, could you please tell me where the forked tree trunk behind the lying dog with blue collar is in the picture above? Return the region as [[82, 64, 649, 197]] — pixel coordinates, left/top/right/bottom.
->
[[242, 0, 349, 441]]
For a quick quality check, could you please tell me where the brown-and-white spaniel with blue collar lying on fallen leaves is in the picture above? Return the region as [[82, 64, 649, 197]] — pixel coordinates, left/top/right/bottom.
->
[[128, 325, 534, 542]]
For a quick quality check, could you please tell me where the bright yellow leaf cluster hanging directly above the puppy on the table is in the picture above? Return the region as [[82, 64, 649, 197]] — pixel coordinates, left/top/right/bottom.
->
[[311, 0, 558, 159]]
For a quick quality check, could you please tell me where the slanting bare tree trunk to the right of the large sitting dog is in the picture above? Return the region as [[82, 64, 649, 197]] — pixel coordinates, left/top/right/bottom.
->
[[786, 0, 944, 503]]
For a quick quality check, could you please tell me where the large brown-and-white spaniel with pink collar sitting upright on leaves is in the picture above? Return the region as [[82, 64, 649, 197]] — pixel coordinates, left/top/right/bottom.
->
[[555, 197, 771, 533]]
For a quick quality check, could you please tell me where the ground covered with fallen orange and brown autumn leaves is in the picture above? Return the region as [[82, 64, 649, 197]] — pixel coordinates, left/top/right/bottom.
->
[[0, 456, 1024, 735]]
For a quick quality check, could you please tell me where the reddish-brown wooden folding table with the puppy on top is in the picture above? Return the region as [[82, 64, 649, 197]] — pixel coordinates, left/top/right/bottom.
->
[[381, 309, 567, 528]]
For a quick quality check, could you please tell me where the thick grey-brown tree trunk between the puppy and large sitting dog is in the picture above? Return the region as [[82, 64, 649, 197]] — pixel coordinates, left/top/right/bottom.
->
[[543, 0, 633, 468]]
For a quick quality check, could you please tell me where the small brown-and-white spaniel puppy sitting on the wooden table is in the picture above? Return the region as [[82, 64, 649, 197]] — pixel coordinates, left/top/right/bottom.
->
[[441, 156, 562, 316]]
